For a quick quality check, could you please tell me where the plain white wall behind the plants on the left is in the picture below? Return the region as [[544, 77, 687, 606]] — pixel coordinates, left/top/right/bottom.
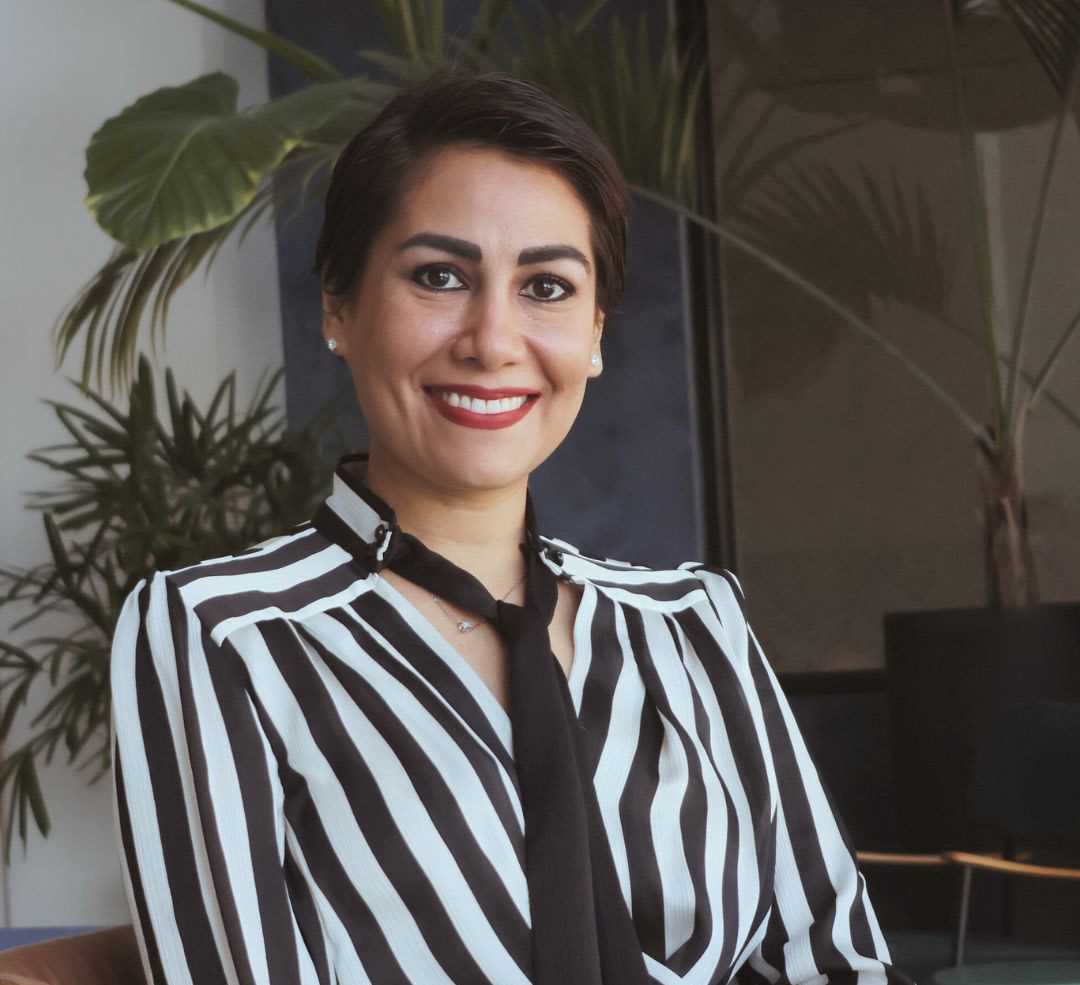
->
[[0, 0, 282, 926]]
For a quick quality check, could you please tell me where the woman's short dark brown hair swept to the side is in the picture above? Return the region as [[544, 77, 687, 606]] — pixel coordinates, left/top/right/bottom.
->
[[315, 69, 629, 313]]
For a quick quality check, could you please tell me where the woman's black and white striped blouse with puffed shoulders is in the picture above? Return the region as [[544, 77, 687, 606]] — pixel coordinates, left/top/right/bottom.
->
[[112, 457, 899, 985]]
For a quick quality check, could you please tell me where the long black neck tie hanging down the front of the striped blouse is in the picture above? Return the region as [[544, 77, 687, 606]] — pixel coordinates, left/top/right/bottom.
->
[[315, 496, 650, 985]]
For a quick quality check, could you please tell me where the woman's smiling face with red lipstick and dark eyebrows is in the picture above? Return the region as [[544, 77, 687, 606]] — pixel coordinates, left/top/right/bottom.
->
[[323, 148, 603, 501]]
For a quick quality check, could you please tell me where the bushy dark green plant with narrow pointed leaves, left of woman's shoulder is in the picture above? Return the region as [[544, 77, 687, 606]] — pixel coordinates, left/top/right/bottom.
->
[[0, 357, 328, 846]]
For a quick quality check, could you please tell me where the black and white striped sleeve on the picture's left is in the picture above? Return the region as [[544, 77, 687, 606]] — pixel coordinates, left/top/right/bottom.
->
[[111, 575, 329, 985]]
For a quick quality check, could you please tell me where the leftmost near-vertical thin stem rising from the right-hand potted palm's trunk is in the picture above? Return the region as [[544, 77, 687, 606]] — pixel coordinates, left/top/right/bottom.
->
[[942, 0, 1009, 448]]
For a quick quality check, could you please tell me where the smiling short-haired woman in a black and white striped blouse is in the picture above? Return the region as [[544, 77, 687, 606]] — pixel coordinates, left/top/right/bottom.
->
[[113, 73, 899, 985]]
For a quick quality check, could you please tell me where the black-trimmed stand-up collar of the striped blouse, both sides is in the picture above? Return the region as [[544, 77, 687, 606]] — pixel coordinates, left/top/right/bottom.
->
[[312, 453, 563, 571]]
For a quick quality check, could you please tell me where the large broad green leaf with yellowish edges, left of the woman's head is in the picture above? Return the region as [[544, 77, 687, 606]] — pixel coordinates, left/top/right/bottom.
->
[[86, 72, 364, 251]]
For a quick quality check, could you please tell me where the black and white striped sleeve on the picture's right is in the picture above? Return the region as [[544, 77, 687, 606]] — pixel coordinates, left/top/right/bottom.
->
[[697, 569, 909, 985]]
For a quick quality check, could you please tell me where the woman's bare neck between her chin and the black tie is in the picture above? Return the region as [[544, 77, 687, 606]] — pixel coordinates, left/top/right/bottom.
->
[[364, 451, 527, 601]]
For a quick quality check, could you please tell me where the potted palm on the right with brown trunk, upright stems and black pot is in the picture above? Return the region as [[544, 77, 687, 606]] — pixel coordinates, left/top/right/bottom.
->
[[885, 0, 1080, 849]]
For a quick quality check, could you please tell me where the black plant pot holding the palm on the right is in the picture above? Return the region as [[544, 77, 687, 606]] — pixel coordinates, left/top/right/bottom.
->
[[885, 603, 1080, 852]]
